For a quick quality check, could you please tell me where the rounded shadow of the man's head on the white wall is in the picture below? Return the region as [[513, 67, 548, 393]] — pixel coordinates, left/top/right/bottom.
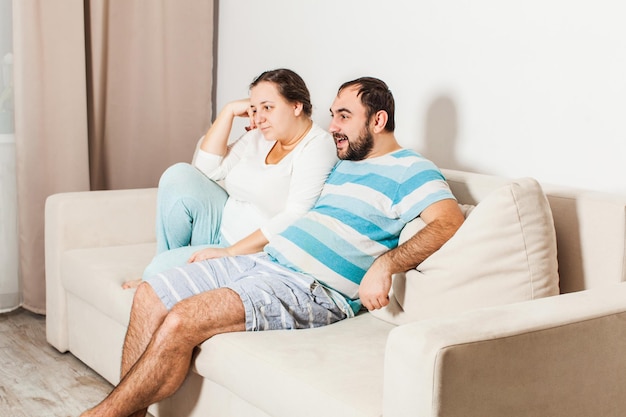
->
[[421, 96, 477, 172]]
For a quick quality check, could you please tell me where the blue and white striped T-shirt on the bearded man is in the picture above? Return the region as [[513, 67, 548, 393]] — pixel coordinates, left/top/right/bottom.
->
[[265, 149, 454, 309]]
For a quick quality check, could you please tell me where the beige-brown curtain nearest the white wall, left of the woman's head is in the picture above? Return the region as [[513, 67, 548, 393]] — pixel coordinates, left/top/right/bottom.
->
[[86, 0, 214, 189]]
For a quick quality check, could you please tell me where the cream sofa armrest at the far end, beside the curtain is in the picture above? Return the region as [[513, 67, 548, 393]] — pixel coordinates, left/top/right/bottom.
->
[[45, 188, 157, 352]]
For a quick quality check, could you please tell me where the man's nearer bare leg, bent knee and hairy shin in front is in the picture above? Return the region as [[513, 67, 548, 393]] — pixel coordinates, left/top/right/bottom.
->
[[82, 288, 245, 417]]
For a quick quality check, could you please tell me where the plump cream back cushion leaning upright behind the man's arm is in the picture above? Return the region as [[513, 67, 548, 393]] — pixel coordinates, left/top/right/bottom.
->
[[373, 178, 559, 324]]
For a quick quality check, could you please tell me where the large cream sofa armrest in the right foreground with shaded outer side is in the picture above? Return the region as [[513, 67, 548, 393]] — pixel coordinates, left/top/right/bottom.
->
[[383, 284, 626, 417]]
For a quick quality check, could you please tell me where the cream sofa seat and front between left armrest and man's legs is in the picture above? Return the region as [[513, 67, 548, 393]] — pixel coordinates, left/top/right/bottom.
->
[[60, 243, 156, 384]]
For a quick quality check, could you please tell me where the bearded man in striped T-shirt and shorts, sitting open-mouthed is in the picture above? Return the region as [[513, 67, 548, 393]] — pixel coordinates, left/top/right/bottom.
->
[[83, 77, 463, 416]]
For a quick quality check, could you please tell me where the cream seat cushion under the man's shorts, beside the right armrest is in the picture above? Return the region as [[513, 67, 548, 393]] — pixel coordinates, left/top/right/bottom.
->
[[195, 313, 396, 417]]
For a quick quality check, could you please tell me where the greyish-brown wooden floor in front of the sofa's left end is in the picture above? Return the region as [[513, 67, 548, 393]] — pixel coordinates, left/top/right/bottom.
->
[[0, 309, 112, 417]]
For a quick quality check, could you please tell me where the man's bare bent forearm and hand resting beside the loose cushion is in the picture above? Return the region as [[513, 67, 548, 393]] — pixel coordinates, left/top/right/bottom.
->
[[359, 199, 464, 310]]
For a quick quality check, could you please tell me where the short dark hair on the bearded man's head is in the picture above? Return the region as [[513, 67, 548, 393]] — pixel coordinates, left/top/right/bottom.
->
[[338, 77, 396, 132]]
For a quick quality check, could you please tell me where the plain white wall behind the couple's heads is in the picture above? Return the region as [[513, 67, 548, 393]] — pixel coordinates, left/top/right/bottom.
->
[[216, 0, 626, 194]]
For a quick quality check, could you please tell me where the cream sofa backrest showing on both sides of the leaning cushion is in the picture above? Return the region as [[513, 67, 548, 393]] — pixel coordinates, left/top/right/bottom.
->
[[442, 169, 626, 293]]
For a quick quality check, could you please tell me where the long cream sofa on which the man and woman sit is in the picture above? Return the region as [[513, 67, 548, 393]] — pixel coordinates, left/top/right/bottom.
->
[[45, 170, 626, 417]]
